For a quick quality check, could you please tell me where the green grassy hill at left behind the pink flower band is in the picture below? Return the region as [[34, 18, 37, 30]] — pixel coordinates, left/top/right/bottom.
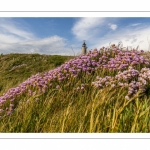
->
[[0, 54, 73, 95]]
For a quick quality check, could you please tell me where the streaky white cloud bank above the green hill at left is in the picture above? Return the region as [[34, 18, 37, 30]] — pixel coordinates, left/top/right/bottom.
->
[[0, 19, 73, 55]]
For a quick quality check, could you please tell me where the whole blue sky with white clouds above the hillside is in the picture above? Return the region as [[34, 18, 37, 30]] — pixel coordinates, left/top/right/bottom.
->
[[0, 17, 150, 55]]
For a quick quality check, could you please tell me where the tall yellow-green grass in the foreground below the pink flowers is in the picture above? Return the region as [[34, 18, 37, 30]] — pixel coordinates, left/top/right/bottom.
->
[[0, 47, 150, 133]]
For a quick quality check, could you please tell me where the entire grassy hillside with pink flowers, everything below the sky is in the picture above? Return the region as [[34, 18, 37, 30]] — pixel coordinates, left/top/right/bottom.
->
[[0, 45, 150, 133]]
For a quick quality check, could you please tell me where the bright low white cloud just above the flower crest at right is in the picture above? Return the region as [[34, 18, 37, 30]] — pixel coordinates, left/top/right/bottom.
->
[[91, 26, 150, 50]]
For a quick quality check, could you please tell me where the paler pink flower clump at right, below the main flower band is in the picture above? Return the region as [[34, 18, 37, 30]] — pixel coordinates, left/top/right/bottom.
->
[[92, 67, 150, 98]]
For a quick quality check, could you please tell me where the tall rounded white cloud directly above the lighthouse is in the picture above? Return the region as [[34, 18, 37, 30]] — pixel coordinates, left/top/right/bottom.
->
[[72, 17, 118, 49]]
